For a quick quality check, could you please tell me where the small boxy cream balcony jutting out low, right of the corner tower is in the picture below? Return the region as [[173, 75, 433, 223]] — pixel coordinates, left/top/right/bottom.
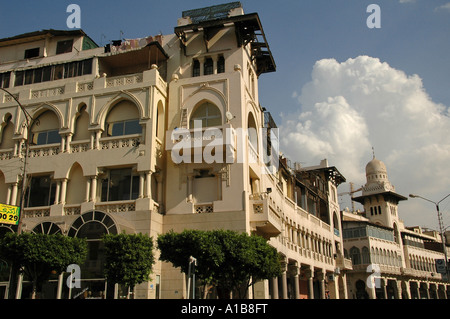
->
[[249, 198, 282, 238]]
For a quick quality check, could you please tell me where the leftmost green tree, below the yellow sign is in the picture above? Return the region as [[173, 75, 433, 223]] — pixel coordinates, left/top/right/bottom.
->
[[0, 233, 87, 299]]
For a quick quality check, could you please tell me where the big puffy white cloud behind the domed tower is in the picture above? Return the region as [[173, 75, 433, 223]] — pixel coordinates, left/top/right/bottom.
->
[[280, 56, 450, 227]]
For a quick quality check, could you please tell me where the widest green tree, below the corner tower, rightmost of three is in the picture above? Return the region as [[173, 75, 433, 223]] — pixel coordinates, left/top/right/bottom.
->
[[157, 230, 281, 298]]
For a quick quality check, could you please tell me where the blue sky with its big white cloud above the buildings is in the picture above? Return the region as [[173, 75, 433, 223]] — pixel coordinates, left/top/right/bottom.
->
[[0, 0, 450, 228]]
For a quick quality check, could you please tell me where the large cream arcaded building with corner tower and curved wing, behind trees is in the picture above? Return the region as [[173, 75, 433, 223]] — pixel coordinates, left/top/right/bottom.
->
[[0, 2, 446, 299]]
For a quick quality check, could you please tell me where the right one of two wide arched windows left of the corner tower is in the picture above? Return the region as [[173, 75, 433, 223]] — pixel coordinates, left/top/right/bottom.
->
[[106, 101, 142, 136]]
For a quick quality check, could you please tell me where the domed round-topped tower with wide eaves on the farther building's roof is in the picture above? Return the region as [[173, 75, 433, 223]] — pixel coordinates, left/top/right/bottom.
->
[[353, 154, 407, 228]]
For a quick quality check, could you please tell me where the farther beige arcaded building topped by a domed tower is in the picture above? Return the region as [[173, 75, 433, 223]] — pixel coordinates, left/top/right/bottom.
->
[[342, 157, 450, 299]]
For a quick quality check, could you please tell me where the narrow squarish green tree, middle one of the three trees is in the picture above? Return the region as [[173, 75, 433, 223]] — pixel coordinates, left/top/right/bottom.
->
[[103, 234, 155, 298]]
